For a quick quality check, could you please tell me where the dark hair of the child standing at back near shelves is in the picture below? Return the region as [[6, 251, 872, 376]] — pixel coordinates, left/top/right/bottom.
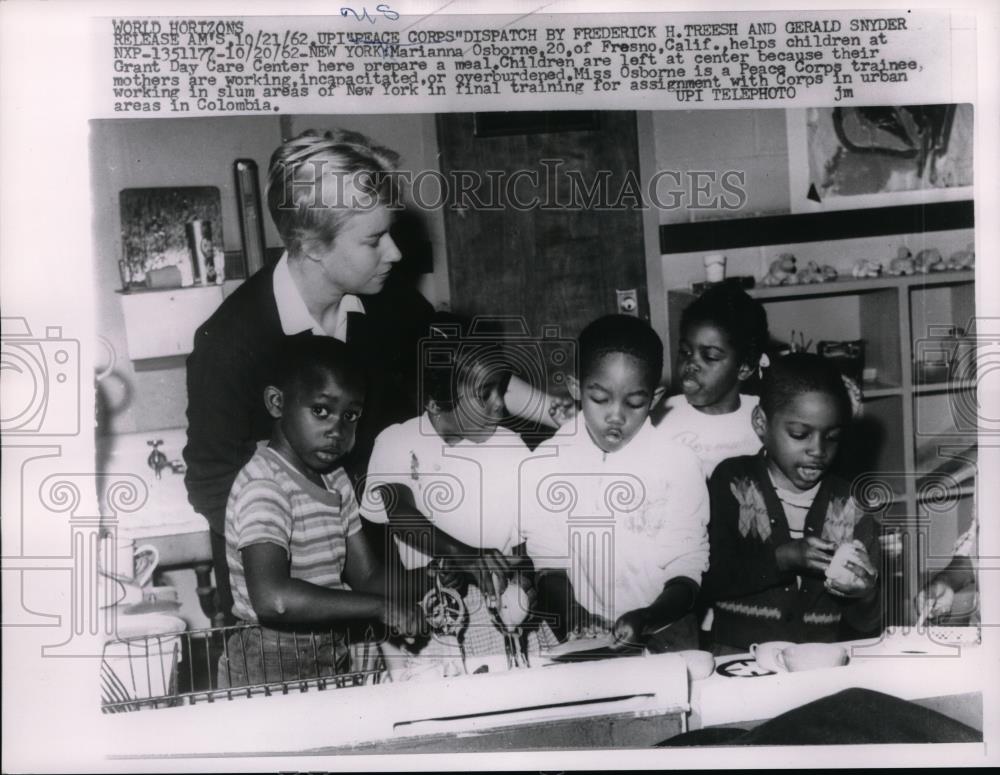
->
[[681, 283, 770, 371]]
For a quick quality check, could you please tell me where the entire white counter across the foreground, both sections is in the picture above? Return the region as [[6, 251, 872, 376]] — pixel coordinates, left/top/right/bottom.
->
[[107, 629, 991, 758]]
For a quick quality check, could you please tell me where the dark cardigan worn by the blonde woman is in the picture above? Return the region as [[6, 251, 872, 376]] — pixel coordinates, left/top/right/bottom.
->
[[184, 267, 433, 534]]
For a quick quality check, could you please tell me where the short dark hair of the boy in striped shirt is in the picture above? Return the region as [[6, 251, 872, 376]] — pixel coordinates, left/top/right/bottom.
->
[[274, 336, 365, 400]]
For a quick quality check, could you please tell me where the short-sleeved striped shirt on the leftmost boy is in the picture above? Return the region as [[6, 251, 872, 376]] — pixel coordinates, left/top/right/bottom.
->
[[226, 447, 361, 622]]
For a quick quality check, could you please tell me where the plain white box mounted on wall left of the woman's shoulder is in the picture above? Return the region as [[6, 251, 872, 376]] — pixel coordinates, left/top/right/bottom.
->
[[118, 285, 223, 361]]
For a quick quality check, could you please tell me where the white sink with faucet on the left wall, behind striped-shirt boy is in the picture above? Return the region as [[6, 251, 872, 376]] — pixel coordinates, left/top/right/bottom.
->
[[97, 428, 212, 567]]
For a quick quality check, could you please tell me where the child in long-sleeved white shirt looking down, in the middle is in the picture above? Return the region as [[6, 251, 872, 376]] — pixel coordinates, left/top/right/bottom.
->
[[521, 315, 708, 650]]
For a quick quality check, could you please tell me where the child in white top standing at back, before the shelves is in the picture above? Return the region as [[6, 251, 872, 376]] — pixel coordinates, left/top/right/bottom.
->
[[656, 284, 769, 480]]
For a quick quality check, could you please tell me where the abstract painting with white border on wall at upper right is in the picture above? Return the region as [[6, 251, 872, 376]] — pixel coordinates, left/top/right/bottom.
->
[[786, 104, 973, 213]]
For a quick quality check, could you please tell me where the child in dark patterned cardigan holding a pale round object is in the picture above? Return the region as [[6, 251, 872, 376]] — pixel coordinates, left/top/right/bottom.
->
[[703, 353, 881, 653]]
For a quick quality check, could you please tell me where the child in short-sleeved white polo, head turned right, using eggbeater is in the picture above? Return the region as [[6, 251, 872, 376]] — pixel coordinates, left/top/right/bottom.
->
[[362, 313, 551, 671]]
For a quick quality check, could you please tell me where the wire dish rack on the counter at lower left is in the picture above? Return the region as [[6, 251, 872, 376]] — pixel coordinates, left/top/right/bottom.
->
[[100, 625, 387, 713]]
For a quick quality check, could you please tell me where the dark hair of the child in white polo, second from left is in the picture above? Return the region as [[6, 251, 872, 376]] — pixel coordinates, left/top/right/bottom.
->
[[419, 312, 511, 411]]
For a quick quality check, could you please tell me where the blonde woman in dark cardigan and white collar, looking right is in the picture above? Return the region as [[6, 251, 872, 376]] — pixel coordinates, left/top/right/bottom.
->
[[184, 130, 433, 621]]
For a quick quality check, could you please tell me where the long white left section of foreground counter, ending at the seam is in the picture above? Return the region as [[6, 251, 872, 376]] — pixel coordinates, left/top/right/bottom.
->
[[106, 654, 689, 757]]
